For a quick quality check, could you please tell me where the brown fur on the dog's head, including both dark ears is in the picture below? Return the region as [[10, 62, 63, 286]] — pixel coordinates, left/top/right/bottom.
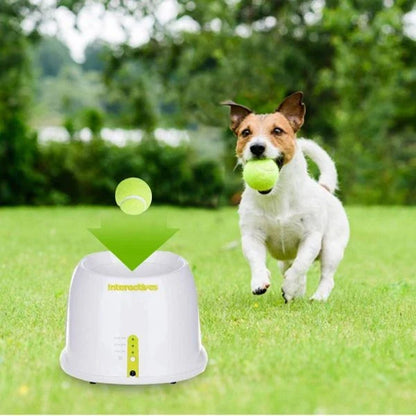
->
[[223, 92, 305, 164]]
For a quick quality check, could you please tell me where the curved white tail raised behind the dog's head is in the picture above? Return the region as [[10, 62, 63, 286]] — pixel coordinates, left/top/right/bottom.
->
[[297, 139, 338, 193]]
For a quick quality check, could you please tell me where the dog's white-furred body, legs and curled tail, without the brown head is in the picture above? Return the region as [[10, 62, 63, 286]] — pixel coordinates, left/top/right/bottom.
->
[[239, 139, 349, 301]]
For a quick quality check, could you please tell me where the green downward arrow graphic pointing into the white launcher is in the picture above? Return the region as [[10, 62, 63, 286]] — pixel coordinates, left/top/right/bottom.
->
[[89, 215, 178, 270]]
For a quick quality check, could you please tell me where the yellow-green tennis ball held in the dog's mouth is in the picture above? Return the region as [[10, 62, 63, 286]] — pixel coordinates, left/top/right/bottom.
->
[[243, 159, 279, 191]]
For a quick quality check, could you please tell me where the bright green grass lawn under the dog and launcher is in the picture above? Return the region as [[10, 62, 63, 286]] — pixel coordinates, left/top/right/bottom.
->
[[0, 207, 416, 414]]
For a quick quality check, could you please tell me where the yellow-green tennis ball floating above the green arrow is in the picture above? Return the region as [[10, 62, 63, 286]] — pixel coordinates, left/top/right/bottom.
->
[[116, 178, 152, 215]]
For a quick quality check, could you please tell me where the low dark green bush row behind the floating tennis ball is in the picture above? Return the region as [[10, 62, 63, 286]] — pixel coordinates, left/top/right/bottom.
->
[[36, 139, 224, 207]]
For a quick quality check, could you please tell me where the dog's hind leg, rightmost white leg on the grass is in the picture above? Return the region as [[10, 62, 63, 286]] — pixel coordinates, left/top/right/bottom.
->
[[310, 243, 344, 301]]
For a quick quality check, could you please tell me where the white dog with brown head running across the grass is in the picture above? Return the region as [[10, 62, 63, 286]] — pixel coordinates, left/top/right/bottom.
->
[[223, 91, 349, 302]]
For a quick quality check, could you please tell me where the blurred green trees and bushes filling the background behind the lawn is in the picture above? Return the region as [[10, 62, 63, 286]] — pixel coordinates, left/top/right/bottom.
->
[[0, 0, 416, 205]]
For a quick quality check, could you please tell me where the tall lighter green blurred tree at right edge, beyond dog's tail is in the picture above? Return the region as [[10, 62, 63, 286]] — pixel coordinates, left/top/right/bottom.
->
[[318, 0, 416, 204]]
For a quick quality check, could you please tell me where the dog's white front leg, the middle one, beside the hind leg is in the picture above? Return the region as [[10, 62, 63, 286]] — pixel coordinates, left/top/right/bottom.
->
[[282, 232, 322, 302]]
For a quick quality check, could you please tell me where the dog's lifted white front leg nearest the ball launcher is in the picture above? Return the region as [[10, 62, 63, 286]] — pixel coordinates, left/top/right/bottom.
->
[[241, 233, 270, 295]]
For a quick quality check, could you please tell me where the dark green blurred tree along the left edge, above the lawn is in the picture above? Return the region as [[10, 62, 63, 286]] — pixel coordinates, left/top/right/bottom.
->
[[0, 0, 40, 205]]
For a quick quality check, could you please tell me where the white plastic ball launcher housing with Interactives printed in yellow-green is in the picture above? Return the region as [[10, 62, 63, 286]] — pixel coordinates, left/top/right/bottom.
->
[[60, 251, 208, 384]]
